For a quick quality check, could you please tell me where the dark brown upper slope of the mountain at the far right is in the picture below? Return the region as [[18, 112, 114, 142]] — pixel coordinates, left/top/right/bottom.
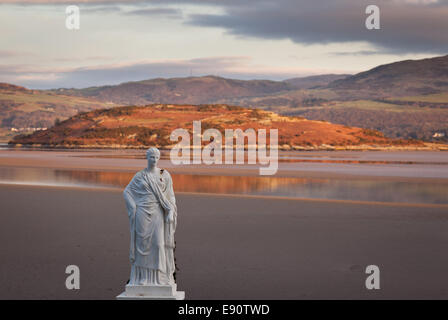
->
[[328, 55, 448, 97]]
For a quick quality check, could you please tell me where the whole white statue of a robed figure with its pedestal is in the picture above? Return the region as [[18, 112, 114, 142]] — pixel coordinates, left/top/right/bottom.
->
[[117, 147, 185, 299]]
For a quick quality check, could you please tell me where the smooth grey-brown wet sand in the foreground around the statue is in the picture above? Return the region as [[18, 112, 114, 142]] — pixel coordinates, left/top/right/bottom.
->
[[0, 185, 448, 299]]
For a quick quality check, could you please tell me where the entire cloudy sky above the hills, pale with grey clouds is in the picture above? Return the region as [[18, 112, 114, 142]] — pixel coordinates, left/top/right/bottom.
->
[[0, 0, 448, 89]]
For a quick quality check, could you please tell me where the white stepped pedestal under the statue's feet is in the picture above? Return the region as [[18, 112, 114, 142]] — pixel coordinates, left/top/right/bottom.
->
[[117, 284, 185, 300]]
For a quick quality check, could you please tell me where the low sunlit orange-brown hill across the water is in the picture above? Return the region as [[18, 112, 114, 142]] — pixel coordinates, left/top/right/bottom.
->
[[10, 104, 424, 149]]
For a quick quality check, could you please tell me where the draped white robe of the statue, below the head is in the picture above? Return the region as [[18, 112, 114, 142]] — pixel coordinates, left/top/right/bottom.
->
[[123, 169, 177, 284]]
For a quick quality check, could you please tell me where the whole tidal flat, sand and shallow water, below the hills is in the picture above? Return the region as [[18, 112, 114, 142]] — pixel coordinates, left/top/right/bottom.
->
[[0, 149, 448, 299]]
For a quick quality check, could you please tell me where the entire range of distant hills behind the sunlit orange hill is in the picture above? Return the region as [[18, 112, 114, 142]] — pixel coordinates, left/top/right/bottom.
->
[[0, 55, 448, 142]]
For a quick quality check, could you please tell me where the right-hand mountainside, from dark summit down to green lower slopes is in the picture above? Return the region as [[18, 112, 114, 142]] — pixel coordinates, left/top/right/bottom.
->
[[228, 56, 448, 143]]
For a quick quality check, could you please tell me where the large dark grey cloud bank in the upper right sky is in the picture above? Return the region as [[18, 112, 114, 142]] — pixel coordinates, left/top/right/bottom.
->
[[187, 0, 448, 53]]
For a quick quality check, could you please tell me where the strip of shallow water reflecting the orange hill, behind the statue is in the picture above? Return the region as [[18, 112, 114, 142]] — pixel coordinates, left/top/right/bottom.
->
[[0, 167, 448, 204]]
